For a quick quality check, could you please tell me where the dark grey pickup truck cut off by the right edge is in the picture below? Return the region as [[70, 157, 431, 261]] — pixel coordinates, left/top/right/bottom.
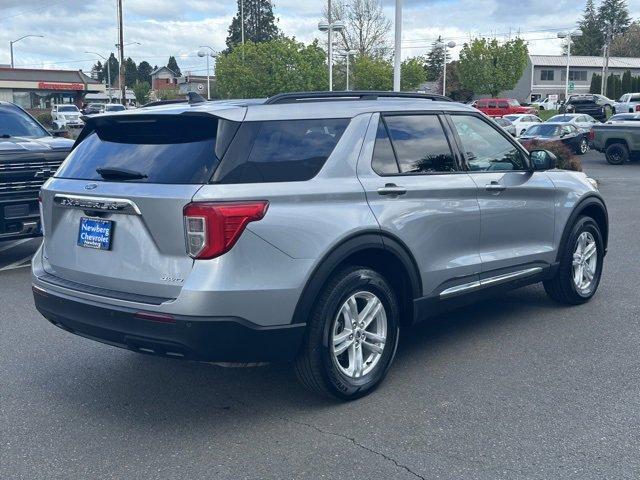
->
[[591, 122, 640, 165]]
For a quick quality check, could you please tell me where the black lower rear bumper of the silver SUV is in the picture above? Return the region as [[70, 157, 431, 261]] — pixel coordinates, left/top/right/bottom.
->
[[33, 286, 305, 362]]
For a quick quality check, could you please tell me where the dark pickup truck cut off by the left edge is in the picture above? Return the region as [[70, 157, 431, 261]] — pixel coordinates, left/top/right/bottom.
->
[[0, 102, 73, 241]]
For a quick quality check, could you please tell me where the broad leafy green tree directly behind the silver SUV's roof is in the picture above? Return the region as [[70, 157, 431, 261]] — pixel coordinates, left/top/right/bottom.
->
[[216, 37, 328, 98]]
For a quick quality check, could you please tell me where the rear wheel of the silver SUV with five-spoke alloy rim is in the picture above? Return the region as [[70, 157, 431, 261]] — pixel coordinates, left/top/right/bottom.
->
[[295, 266, 400, 400]]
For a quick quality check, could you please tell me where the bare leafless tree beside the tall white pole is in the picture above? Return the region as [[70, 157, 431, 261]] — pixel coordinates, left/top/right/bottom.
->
[[324, 0, 391, 58]]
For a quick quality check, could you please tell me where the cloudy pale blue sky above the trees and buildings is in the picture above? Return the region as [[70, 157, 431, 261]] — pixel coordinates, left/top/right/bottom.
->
[[0, 0, 640, 73]]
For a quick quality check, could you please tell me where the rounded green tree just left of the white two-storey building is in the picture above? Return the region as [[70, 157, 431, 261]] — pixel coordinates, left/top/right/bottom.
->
[[459, 38, 528, 97]]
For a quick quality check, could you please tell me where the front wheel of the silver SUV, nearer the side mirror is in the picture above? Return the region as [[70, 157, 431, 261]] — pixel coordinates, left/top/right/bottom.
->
[[543, 216, 604, 305]]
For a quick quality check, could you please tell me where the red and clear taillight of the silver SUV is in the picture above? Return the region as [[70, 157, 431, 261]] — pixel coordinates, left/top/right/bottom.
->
[[183, 201, 269, 260]]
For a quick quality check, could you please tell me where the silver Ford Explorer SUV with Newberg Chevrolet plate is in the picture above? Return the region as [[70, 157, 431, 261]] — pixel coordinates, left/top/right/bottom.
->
[[33, 92, 608, 399]]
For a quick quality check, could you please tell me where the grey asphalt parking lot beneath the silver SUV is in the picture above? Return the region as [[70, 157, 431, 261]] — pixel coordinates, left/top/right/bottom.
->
[[0, 152, 640, 479]]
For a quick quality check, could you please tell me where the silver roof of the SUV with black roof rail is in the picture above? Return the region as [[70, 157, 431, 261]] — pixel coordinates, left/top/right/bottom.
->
[[97, 91, 477, 121]]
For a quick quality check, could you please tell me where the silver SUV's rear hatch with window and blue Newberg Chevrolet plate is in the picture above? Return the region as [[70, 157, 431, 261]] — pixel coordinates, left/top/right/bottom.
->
[[42, 112, 239, 301]]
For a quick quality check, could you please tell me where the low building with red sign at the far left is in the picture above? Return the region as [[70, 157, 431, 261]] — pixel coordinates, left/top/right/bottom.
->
[[0, 67, 105, 110]]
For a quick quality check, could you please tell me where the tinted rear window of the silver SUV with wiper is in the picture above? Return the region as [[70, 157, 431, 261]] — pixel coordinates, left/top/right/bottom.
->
[[55, 115, 239, 184]]
